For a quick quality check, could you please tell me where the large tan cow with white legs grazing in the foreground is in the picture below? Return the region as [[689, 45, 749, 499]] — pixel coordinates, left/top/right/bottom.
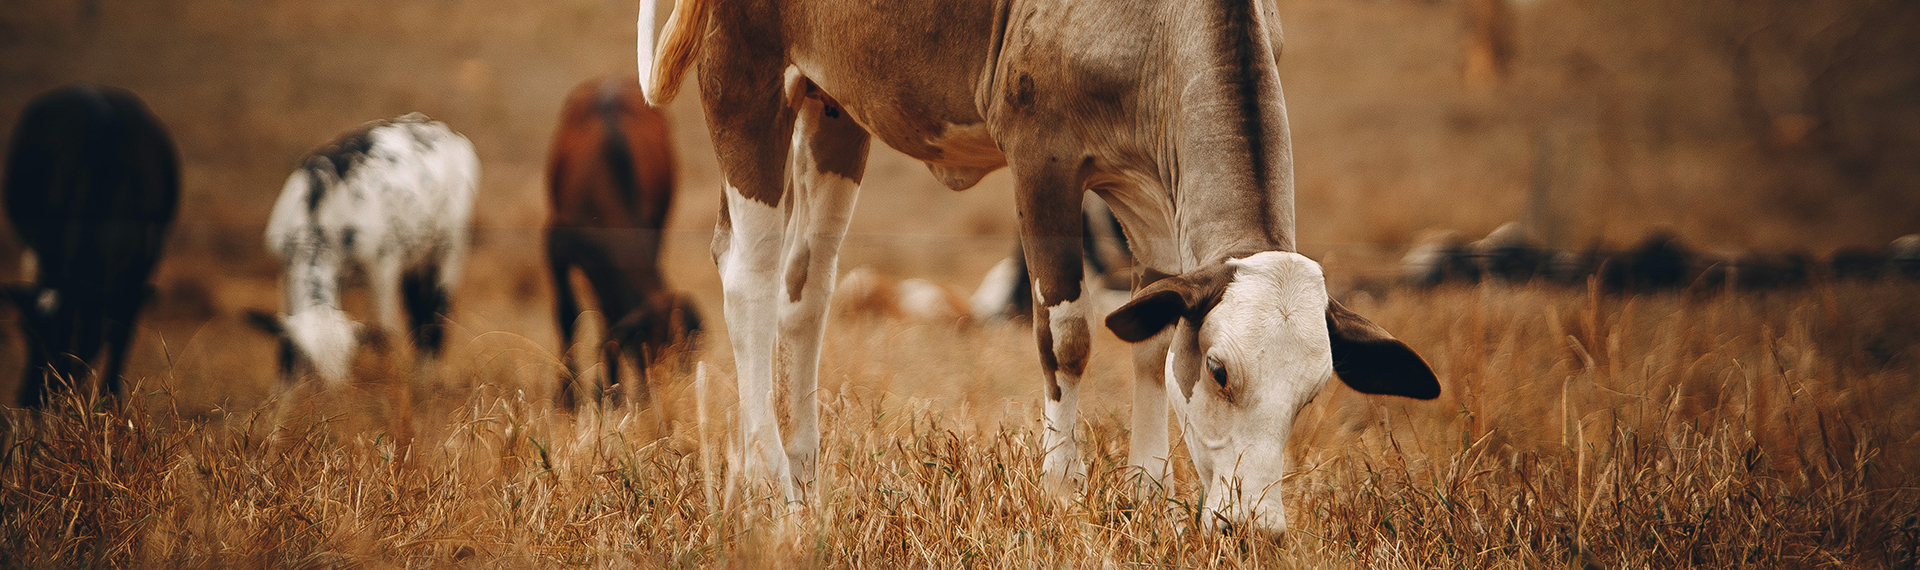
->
[[639, 0, 1440, 532]]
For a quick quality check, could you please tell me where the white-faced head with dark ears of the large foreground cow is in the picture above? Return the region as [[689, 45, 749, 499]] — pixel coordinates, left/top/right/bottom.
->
[[1106, 251, 1440, 534]]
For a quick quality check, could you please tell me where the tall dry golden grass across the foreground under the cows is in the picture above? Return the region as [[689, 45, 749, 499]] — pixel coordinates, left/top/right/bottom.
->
[[0, 284, 1920, 568]]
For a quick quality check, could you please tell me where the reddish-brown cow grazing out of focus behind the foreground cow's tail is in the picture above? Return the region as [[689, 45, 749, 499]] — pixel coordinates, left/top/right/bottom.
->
[[547, 77, 701, 409]]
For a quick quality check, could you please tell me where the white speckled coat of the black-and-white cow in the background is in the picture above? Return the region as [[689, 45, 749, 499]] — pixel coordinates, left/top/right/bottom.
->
[[267, 113, 480, 384]]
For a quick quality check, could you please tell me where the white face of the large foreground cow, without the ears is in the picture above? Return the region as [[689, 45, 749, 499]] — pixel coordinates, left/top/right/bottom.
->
[[1165, 251, 1332, 532]]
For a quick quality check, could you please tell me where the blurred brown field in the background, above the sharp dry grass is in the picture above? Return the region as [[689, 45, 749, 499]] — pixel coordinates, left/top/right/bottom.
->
[[0, 0, 1920, 409]]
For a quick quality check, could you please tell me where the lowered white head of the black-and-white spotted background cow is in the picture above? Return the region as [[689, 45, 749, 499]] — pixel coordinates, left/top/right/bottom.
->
[[248, 307, 368, 386]]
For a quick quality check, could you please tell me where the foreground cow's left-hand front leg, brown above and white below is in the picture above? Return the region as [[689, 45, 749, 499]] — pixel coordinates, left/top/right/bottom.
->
[[1014, 161, 1092, 491]]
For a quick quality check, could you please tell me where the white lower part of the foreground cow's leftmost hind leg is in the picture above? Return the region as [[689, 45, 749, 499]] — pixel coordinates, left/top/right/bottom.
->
[[718, 184, 795, 499]]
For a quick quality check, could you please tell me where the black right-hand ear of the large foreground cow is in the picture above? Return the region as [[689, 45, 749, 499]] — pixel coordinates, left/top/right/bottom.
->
[[1327, 299, 1440, 399]]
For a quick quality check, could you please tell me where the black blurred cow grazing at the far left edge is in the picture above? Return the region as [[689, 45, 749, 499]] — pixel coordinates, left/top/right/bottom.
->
[[6, 84, 180, 407]]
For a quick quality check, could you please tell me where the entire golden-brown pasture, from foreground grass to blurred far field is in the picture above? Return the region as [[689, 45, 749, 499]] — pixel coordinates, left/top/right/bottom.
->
[[0, 0, 1920, 568]]
